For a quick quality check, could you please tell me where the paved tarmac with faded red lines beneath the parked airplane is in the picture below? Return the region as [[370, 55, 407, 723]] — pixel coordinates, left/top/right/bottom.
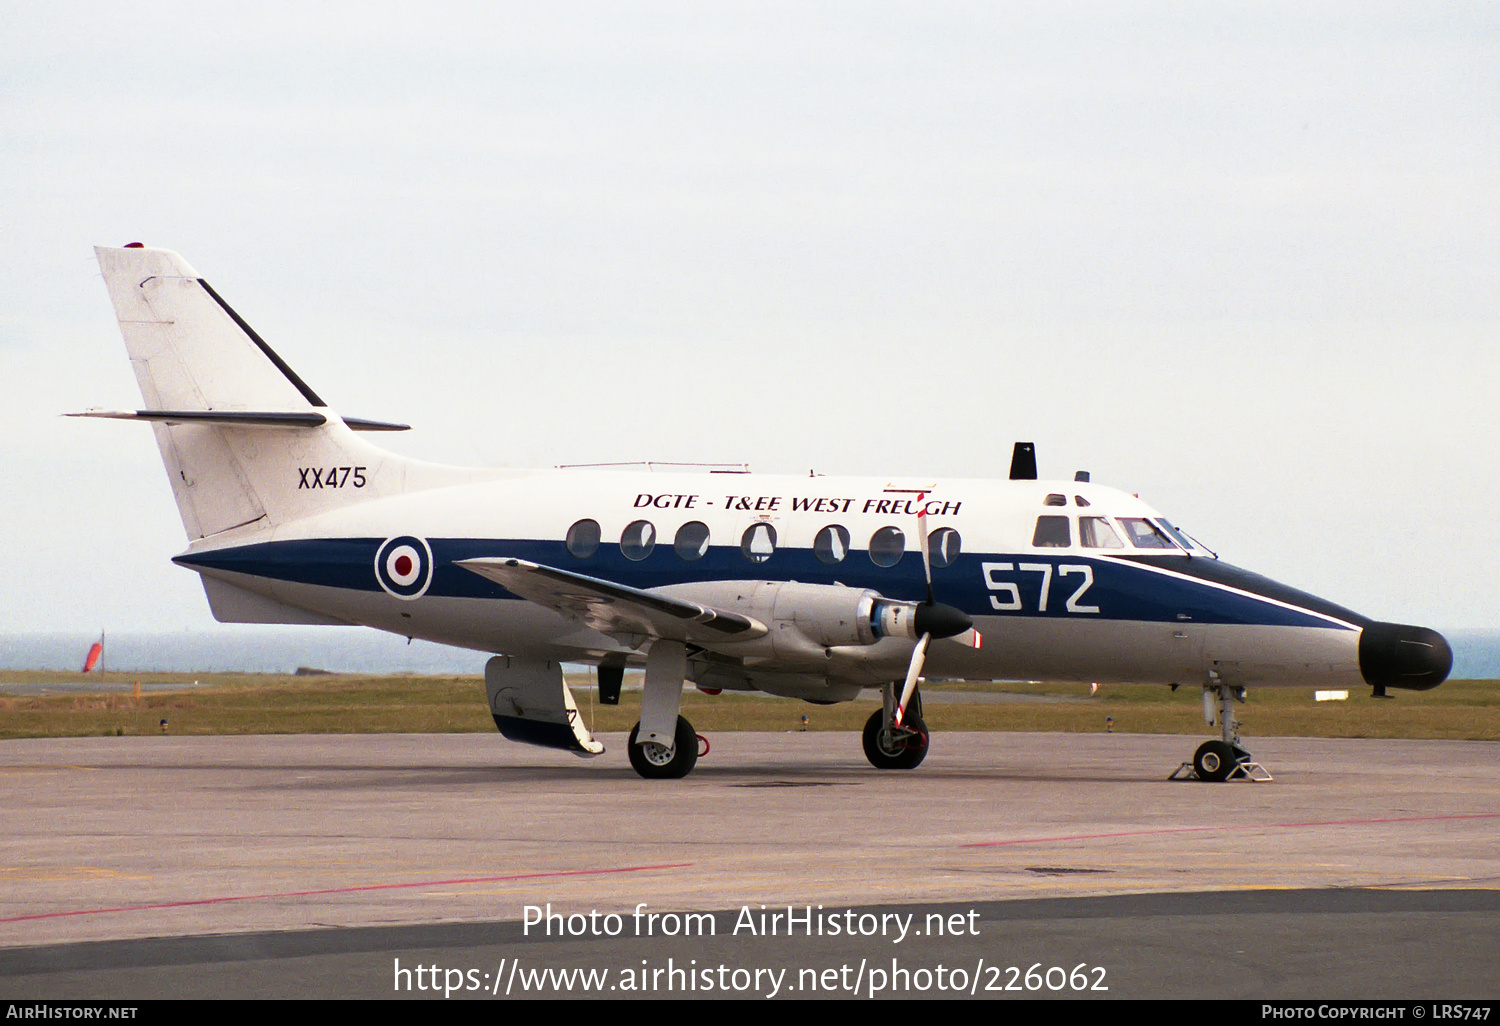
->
[[0, 732, 1500, 999]]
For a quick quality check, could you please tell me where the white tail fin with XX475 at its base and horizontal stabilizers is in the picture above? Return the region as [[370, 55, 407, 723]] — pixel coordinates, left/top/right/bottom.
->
[[90, 246, 468, 540]]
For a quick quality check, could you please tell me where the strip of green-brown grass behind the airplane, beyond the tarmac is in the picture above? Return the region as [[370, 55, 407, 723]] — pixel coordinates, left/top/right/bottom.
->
[[0, 672, 1500, 741]]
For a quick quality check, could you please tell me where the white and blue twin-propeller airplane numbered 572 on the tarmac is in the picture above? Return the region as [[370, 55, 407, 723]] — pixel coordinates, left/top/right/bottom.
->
[[71, 243, 1452, 782]]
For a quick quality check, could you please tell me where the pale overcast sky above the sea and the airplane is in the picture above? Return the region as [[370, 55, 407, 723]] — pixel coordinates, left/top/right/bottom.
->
[[0, 0, 1500, 630]]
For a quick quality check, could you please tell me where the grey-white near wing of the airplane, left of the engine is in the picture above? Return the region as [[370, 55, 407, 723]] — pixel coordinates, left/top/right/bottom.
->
[[458, 558, 770, 644]]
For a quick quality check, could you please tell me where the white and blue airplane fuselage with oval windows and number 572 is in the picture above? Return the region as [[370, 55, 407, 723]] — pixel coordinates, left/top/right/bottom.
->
[[177, 468, 1442, 698]]
